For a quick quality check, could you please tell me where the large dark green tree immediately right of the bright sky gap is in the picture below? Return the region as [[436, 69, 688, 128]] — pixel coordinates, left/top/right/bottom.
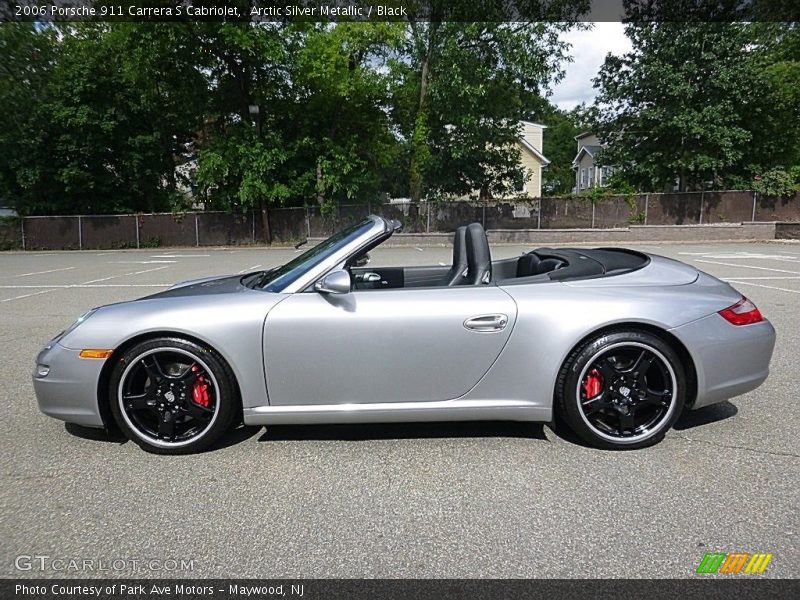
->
[[595, 22, 763, 190]]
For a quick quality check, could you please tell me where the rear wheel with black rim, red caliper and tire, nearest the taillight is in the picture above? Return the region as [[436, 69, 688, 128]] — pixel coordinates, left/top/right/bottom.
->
[[555, 330, 686, 450]]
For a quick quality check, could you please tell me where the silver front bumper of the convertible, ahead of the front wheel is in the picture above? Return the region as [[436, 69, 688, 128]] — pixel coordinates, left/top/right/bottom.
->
[[33, 341, 106, 427]]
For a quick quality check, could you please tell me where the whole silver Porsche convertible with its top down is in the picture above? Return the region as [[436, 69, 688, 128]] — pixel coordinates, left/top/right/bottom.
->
[[33, 216, 775, 454]]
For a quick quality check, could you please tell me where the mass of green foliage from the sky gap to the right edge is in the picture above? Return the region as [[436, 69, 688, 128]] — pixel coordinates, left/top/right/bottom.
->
[[593, 15, 800, 191]]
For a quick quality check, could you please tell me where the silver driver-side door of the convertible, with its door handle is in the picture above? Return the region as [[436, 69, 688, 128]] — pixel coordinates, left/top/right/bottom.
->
[[264, 285, 517, 406]]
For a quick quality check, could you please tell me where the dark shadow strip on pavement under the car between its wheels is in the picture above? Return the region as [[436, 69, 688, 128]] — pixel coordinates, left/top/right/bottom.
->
[[258, 421, 547, 442]]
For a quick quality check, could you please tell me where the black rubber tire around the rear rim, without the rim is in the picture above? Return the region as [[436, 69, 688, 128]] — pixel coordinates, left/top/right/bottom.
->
[[556, 330, 686, 450]]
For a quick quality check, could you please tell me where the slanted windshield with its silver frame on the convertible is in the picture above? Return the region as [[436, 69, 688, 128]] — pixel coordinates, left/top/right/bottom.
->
[[258, 215, 394, 294]]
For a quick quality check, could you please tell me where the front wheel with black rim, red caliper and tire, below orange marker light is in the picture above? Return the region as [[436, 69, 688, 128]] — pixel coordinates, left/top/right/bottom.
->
[[108, 337, 240, 454]]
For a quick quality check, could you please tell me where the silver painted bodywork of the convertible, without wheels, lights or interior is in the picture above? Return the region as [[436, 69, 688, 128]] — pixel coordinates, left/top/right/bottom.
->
[[34, 217, 775, 434]]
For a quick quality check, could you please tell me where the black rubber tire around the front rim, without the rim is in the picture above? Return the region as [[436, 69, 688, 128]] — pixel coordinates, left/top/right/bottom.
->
[[108, 337, 238, 454]]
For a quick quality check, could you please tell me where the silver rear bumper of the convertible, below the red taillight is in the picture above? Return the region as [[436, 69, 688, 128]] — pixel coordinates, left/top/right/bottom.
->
[[670, 313, 775, 408]]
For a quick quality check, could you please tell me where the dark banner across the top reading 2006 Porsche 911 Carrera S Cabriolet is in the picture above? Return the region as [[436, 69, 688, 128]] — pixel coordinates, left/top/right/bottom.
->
[[0, 0, 800, 23]]
